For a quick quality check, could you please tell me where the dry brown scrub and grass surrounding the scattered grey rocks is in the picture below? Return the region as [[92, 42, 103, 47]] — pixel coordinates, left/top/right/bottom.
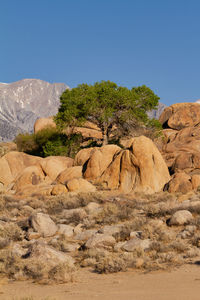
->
[[0, 192, 200, 283]]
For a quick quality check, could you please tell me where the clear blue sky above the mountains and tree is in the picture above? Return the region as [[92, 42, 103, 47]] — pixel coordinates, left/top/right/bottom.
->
[[0, 0, 200, 105]]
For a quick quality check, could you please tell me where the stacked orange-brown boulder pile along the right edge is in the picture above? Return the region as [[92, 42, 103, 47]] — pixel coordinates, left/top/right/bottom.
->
[[160, 103, 200, 193]]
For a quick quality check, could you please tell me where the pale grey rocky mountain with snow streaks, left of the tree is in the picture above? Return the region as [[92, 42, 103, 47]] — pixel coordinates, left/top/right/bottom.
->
[[0, 79, 69, 141]]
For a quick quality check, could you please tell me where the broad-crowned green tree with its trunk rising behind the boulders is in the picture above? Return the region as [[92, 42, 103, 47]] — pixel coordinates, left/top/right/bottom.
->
[[55, 81, 159, 145]]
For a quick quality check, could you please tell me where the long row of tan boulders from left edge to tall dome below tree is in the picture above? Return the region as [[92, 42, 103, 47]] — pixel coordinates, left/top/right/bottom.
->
[[0, 136, 170, 196]]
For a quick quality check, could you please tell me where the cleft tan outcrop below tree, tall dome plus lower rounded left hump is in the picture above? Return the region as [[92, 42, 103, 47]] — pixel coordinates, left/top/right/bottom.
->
[[83, 136, 170, 193]]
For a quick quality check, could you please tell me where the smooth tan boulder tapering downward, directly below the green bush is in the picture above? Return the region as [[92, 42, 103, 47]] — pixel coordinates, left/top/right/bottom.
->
[[40, 156, 74, 181]]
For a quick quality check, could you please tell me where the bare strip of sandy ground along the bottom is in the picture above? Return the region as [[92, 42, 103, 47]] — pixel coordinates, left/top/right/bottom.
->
[[0, 265, 200, 300]]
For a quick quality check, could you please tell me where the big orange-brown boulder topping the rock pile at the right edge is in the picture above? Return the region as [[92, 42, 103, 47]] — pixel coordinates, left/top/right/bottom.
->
[[159, 103, 200, 130]]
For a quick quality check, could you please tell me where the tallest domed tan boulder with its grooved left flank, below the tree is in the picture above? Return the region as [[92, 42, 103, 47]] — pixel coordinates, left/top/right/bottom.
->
[[99, 136, 170, 193]]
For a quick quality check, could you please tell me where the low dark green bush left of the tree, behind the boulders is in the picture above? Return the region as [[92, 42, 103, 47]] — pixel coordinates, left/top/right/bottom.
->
[[15, 127, 82, 157]]
